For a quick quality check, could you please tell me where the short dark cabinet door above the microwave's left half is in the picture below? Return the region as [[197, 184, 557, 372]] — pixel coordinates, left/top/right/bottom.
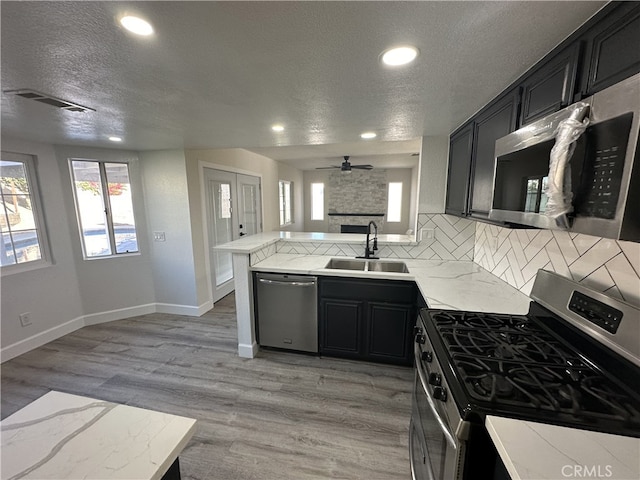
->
[[520, 42, 580, 126]]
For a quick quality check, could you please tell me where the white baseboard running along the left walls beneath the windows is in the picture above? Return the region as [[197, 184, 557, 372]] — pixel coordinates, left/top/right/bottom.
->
[[0, 301, 211, 363]]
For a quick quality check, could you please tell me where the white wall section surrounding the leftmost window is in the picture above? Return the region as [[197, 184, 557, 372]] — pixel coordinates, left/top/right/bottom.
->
[[0, 137, 83, 352]]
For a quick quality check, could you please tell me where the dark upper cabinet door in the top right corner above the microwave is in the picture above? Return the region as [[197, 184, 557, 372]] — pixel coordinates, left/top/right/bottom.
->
[[579, 2, 640, 98]]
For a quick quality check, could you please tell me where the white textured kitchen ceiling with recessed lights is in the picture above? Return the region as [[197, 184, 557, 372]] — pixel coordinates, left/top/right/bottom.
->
[[0, 0, 605, 168]]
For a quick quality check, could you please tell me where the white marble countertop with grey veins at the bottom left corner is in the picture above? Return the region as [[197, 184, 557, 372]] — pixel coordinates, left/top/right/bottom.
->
[[1, 391, 196, 480]]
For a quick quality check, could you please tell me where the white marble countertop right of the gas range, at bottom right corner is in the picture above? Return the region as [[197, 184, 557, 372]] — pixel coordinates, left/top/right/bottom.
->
[[485, 416, 640, 480]]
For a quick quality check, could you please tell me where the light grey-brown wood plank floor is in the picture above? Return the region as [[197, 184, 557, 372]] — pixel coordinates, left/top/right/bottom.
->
[[1, 295, 413, 480]]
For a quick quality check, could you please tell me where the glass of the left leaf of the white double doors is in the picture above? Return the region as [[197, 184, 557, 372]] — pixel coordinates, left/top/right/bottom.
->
[[210, 180, 233, 286]]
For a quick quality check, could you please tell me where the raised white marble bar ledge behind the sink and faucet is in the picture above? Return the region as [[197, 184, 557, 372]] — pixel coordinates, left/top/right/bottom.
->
[[215, 232, 418, 254]]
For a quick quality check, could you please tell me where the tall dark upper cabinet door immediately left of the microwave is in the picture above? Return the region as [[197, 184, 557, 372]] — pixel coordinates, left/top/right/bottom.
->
[[469, 89, 520, 219]]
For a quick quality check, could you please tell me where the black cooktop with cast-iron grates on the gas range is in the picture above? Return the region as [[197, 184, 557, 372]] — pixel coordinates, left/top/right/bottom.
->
[[423, 310, 640, 437]]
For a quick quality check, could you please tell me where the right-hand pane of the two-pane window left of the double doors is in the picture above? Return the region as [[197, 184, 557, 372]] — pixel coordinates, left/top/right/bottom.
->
[[105, 163, 138, 253]]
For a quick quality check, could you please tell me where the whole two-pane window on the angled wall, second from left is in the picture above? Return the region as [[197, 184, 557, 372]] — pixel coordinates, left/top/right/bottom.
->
[[70, 159, 138, 258]]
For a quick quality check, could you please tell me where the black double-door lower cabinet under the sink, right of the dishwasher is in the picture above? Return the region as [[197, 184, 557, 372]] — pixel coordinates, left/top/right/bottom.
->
[[319, 277, 416, 365]]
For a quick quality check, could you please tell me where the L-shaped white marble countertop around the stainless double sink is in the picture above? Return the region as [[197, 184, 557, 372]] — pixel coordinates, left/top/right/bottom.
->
[[251, 253, 530, 314]]
